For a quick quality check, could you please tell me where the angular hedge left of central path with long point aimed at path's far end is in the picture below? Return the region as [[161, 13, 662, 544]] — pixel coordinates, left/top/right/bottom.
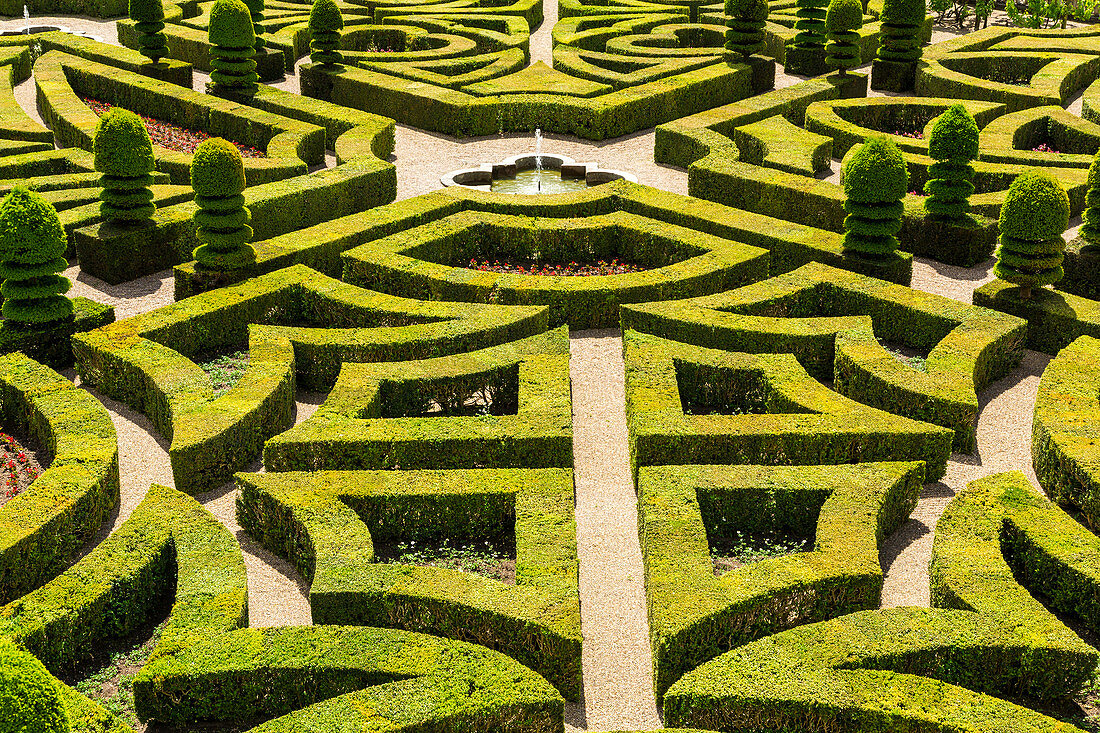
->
[[74, 265, 547, 493]]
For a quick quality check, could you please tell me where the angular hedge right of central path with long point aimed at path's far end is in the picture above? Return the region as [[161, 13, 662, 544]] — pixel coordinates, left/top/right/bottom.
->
[[623, 256, 1026, 452]]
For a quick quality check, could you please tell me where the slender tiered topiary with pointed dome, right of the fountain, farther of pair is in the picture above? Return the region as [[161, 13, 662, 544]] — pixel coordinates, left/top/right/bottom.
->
[[924, 105, 978, 225]]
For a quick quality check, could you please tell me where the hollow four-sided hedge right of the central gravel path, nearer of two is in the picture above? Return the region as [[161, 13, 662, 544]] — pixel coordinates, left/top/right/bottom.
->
[[638, 462, 924, 696]]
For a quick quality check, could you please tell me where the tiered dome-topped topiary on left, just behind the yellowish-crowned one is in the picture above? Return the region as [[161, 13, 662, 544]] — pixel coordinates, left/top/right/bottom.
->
[[91, 107, 156, 225]]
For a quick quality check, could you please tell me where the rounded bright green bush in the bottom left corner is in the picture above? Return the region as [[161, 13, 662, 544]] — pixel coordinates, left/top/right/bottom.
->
[[0, 638, 70, 733]]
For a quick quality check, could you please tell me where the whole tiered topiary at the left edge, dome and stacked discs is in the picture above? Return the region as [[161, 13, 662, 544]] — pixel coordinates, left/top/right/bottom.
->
[[0, 186, 73, 326]]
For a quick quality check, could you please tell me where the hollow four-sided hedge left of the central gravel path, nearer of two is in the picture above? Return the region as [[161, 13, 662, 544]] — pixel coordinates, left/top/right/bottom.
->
[[237, 464, 581, 699]]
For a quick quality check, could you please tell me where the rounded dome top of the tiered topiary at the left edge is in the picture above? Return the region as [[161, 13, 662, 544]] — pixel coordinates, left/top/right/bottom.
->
[[0, 186, 66, 264]]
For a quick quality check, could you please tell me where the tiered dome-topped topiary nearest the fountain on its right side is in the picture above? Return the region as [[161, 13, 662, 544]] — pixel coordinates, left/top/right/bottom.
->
[[843, 138, 909, 260]]
